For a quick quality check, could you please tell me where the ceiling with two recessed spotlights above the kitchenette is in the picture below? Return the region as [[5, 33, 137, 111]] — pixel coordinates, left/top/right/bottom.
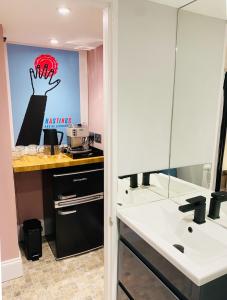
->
[[0, 0, 102, 50]]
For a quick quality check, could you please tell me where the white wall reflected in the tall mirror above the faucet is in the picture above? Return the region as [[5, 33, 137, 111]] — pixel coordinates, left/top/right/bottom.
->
[[170, 10, 225, 167]]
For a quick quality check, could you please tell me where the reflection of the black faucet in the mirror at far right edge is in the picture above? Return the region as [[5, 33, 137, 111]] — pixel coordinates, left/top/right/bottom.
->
[[208, 192, 227, 220]]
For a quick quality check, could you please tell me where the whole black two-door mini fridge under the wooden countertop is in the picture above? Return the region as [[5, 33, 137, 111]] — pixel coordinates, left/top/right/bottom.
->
[[43, 163, 104, 259]]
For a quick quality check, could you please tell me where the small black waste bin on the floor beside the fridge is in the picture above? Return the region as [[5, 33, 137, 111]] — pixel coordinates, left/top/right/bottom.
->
[[23, 219, 42, 260]]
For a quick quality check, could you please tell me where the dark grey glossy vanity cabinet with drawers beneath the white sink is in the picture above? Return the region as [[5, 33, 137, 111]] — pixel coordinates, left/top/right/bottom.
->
[[118, 221, 227, 300]]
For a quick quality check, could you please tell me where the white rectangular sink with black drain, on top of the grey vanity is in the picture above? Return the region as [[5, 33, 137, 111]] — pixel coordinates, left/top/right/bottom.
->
[[117, 199, 227, 286]]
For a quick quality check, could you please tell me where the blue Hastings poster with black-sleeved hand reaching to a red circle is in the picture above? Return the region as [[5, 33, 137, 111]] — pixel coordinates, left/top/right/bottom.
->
[[7, 44, 80, 146]]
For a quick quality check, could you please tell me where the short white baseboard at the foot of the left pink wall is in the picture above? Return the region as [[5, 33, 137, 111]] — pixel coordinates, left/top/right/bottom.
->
[[1, 256, 23, 282]]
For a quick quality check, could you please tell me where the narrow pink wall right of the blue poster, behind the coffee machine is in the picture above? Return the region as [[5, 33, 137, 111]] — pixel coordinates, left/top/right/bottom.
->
[[87, 46, 104, 149]]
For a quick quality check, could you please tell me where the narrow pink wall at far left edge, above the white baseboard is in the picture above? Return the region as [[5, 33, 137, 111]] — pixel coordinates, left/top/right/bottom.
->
[[0, 25, 19, 261]]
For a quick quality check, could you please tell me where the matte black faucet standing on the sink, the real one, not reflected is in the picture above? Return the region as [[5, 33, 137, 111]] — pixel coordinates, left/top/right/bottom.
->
[[178, 196, 206, 224]]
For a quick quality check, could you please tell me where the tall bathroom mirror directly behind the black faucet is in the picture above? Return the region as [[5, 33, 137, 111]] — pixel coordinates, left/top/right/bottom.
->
[[169, 0, 226, 199]]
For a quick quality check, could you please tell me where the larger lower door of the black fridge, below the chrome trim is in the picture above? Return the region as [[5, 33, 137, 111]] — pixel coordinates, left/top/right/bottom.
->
[[55, 199, 104, 258]]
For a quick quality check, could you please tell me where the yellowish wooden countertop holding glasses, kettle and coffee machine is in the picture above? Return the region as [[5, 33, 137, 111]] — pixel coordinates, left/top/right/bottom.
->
[[13, 154, 104, 173]]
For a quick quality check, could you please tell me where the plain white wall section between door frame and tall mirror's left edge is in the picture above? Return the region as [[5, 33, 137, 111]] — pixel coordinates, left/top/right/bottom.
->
[[117, 0, 177, 175]]
